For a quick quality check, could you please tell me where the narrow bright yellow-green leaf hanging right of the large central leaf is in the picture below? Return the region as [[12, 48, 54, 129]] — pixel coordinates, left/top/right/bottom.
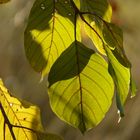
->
[[105, 46, 130, 114]]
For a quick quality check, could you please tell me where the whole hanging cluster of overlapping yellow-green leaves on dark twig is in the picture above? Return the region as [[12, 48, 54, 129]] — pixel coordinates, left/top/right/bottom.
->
[[25, 0, 135, 132]]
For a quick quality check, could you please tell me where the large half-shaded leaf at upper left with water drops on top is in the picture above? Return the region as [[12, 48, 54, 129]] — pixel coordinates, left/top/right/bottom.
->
[[24, 0, 80, 76]]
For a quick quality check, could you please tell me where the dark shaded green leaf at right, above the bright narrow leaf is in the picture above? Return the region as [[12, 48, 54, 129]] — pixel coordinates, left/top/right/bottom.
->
[[103, 22, 131, 67]]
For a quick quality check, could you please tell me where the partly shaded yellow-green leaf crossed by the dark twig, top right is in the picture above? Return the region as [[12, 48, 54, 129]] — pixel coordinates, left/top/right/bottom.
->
[[81, 0, 112, 54]]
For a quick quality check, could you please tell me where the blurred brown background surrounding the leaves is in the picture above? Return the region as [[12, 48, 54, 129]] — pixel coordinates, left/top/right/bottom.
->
[[0, 0, 140, 140]]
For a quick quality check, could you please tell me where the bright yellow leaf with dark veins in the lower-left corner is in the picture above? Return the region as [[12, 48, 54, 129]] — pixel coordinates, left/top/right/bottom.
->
[[0, 80, 60, 140]]
